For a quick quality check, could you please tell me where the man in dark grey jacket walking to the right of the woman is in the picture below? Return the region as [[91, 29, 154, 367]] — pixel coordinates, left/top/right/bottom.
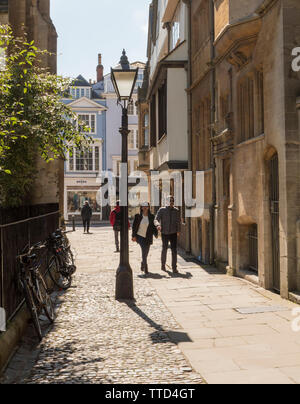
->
[[155, 196, 181, 274]]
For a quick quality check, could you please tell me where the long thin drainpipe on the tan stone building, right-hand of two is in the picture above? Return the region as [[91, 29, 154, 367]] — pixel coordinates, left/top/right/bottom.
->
[[210, 0, 217, 265]]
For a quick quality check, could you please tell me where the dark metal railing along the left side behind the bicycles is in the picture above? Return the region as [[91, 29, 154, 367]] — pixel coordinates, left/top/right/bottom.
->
[[0, 204, 59, 321]]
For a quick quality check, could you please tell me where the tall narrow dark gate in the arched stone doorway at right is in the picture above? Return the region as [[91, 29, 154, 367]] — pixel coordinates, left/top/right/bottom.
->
[[270, 154, 280, 292]]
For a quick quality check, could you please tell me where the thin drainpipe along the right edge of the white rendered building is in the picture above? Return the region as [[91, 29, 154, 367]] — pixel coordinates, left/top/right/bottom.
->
[[183, 0, 193, 253]]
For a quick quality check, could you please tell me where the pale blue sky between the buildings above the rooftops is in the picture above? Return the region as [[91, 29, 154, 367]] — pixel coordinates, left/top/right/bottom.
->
[[50, 0, 151, 80]]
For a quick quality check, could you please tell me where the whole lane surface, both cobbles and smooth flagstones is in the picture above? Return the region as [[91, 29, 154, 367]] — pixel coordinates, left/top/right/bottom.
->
[[3, 227, 300, 384]]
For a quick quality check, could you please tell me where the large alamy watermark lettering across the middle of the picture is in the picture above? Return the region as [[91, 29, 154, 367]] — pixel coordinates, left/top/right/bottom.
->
[[97, 167, 207, 218]]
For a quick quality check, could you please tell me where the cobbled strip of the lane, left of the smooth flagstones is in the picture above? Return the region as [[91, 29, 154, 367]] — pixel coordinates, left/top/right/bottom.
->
[[0, 228, 202, 384]]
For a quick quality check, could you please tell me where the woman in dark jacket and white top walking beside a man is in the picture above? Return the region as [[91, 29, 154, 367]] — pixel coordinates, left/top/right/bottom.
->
[[132, 202, 158, 274]]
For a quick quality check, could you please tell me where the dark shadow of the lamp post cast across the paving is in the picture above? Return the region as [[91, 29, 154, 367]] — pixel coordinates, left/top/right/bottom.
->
[[123, 300, 193, 345]]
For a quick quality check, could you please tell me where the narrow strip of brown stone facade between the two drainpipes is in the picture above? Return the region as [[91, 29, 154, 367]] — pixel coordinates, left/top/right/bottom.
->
[[188, 0, 214, 264]]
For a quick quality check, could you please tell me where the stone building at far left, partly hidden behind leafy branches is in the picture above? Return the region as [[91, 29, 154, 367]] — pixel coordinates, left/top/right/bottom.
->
[[4, 0, 64, 218]]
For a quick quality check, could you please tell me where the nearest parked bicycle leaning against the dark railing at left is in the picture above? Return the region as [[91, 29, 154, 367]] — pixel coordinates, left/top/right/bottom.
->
[[17, 243, 55, 340]]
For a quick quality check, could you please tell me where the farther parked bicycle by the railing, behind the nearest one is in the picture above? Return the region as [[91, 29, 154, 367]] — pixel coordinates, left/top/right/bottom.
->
[[46, 229, 76, 290]]
